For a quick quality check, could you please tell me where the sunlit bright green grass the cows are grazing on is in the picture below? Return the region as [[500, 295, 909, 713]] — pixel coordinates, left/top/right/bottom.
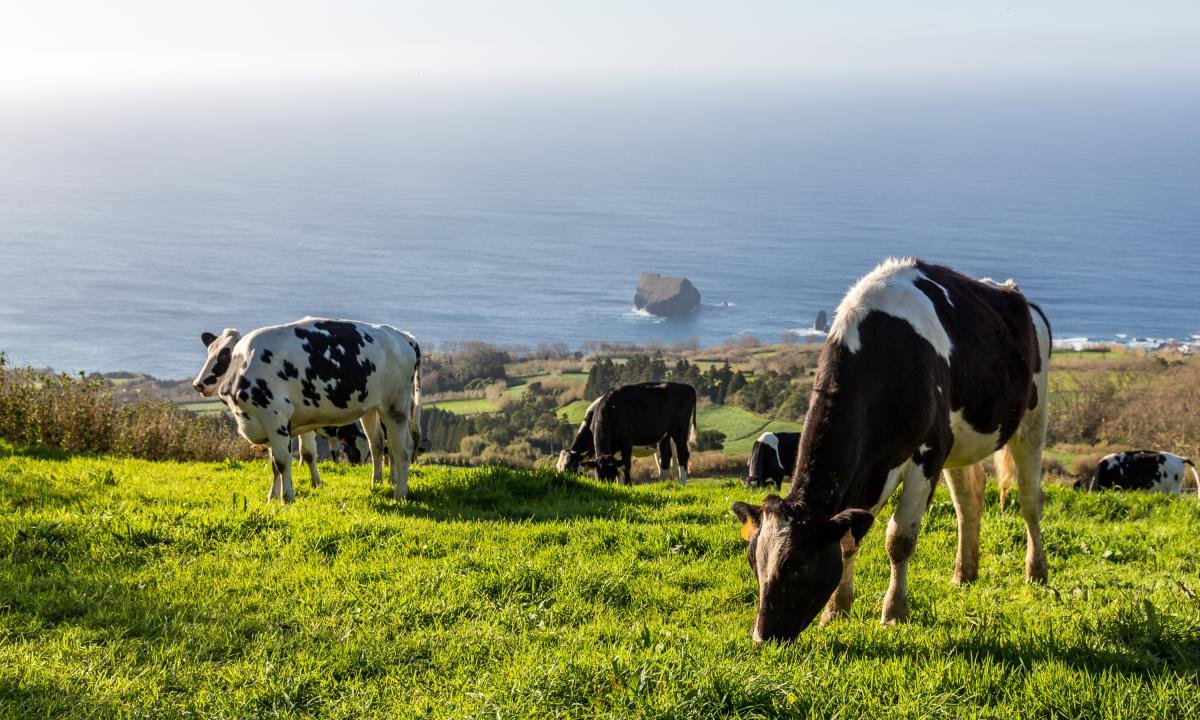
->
[[0, 446, 1200, 719]]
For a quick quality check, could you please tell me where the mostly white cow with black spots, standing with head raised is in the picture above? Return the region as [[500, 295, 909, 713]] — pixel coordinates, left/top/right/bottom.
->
[[193, 318, 421, 503]]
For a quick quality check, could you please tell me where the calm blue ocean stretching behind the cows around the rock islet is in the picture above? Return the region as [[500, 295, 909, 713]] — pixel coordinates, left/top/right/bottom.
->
[[0, 82, 1200, 378]]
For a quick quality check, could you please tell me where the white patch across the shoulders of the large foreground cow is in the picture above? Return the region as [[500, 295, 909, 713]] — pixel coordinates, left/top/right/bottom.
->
[[829, 258, 953, 362]]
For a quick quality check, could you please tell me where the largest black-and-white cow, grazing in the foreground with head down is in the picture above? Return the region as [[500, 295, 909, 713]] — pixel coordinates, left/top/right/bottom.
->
[[733, 258, 1050, 642]]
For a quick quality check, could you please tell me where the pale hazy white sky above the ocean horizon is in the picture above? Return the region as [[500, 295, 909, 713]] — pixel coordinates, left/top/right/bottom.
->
[[0, 0, 1200, 94]]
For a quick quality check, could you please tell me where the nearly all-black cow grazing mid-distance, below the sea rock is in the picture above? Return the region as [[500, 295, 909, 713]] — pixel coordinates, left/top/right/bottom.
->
[[582, 383, 696, 485]]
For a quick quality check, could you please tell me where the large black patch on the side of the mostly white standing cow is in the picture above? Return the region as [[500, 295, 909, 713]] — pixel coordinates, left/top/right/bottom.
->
[[295, 320, 376, 409]]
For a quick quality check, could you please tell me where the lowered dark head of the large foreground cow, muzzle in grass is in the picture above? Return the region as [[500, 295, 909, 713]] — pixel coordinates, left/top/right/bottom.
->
[[733, 496, 875, 642]]
